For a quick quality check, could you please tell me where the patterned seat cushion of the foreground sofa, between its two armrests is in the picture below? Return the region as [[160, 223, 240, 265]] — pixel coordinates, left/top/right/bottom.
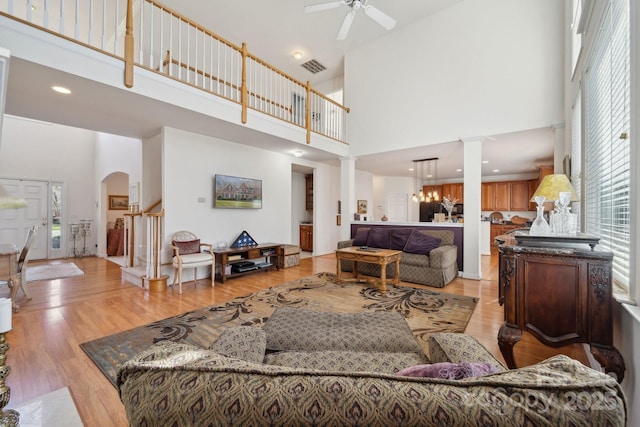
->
[[264, 350, 429, 374]]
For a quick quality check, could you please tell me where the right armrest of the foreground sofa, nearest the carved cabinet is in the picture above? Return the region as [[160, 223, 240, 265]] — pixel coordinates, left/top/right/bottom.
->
[[427, 333, 506, 371]]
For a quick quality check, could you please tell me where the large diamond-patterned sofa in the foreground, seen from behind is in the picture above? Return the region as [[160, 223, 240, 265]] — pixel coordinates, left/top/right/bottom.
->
[[118, 308, 626, 426]]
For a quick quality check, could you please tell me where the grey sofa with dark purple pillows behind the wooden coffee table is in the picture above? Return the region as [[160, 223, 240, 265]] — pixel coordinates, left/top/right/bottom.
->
[[338, 227, 458, 288]]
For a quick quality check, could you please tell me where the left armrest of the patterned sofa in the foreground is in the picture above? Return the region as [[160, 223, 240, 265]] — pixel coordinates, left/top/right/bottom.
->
[[209, 326, 267, 363]]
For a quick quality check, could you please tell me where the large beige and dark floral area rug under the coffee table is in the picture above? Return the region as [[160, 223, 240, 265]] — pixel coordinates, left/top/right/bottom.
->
[[80, 273, 478, 386]]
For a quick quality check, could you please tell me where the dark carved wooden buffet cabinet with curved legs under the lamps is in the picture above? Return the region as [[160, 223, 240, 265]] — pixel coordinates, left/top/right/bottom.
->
[[498, 244, 625, 382]]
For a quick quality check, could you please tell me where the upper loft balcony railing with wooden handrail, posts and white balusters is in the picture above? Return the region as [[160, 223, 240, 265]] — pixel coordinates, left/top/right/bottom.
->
[[0, 0, 350, 143]]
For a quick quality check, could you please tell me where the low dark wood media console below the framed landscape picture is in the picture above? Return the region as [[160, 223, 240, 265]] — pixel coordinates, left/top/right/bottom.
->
[[213, 243, 284, 283]]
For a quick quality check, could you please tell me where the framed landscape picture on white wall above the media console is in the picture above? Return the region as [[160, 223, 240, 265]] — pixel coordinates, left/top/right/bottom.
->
[[213, 175, 262, 209]]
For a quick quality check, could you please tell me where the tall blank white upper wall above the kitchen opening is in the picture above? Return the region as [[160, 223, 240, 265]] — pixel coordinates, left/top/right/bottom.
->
[[345, 0, 564, 156]]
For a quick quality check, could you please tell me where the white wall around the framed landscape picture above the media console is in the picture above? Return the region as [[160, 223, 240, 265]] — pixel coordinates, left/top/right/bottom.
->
[[163, 128, 337, 254]]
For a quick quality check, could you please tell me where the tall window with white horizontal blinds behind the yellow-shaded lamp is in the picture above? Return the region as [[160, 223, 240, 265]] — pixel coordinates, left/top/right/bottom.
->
[[584, 0, 631, 289]]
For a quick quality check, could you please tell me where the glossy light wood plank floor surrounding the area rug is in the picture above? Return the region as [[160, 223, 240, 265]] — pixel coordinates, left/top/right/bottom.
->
[[0, 254, 586, 426]]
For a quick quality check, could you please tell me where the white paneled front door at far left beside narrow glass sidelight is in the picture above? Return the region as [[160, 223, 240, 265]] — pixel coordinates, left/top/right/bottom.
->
[[0, 179, 49, 259]]
